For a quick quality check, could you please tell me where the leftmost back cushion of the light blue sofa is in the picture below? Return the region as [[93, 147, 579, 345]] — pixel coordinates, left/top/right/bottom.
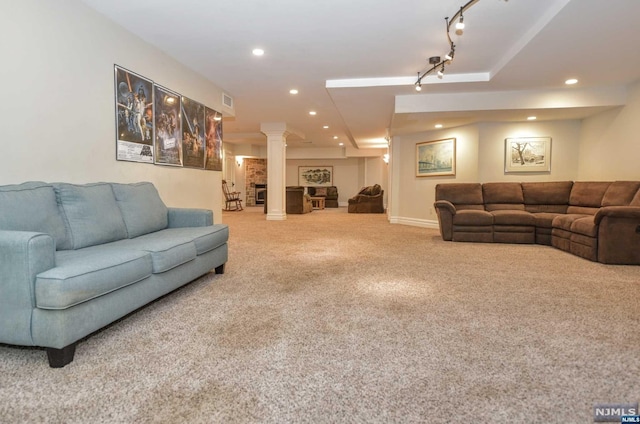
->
[[0, 181, 70, 250]]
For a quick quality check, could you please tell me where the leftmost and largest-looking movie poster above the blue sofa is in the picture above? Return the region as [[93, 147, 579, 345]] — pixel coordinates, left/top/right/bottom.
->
[[114, 65, 154, 163]]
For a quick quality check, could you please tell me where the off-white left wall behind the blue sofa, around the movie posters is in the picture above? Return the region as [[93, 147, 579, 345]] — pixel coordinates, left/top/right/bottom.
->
[[0, 0, 233, 222]]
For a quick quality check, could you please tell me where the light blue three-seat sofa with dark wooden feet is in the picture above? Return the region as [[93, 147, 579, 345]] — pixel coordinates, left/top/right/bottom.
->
[[0, 182, 229, 368]]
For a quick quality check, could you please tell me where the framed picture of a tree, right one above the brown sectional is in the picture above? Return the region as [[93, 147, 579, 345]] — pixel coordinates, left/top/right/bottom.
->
[[504, 137, 551, 173]]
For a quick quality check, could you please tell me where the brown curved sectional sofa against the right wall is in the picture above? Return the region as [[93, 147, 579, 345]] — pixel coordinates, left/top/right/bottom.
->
[[434, 181, 640, 265]]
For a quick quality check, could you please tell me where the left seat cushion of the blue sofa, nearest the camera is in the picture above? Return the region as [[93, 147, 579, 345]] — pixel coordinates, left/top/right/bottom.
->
[[36, 245, 152, 309]]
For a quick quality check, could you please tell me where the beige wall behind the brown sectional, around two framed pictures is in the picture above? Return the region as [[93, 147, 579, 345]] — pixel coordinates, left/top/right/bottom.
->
[[389, 120, 581, 227]]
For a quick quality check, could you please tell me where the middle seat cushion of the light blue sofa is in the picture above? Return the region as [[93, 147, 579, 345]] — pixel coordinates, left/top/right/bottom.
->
[[111, 230, 197, 274]]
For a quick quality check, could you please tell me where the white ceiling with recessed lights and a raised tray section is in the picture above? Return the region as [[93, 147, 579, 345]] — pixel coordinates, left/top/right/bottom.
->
[[82, 0, 640, 152]]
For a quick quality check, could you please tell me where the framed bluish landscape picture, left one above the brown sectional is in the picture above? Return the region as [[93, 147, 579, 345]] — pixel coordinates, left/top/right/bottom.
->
[[416, 138, 456, 177]]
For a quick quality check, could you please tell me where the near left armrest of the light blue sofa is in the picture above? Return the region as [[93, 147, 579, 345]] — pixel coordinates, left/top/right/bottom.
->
[[0, 230, 56, 346]]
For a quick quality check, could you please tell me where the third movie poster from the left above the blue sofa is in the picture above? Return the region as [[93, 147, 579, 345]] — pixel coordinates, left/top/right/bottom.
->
[[180, 96, 204, 169]]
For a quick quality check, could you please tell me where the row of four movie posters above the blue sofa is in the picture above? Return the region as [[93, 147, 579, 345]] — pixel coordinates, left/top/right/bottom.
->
[[115, 65, 222, 171]]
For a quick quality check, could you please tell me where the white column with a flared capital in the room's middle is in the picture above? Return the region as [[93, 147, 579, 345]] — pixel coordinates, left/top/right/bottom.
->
[[260, 122, 304, 221]]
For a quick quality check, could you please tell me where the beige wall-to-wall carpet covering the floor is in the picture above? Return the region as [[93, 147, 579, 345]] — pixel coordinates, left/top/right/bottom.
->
[[0, 208, 640, 423]]
